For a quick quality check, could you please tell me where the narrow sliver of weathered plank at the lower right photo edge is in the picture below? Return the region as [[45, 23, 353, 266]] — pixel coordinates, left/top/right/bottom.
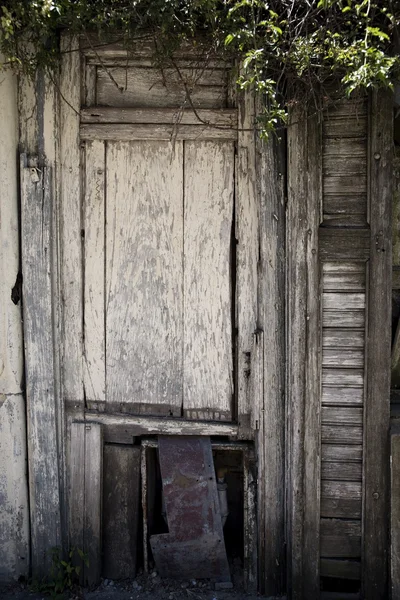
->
[[390, 428, 400, 598]]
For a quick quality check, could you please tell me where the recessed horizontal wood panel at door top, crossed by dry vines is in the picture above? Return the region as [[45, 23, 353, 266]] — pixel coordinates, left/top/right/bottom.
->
[[96, 66, 228, 108]]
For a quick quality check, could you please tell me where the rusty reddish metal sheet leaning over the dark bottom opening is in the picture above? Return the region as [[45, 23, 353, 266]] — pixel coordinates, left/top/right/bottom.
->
[[150, 436, 230, 583]]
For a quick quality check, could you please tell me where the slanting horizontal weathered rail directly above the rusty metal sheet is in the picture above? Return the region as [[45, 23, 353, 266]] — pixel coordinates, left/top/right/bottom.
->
[[81, 411, 238, 438]]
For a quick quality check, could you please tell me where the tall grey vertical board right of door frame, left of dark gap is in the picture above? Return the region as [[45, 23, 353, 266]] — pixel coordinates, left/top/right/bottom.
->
[[256, 125, 286, 596]]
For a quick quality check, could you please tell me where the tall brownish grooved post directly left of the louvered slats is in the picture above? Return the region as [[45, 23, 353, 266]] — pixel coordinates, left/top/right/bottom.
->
[[286, 109, 322, 599]]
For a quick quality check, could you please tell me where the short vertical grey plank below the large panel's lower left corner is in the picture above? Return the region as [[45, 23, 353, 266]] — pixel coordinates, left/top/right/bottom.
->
[[83, 423, 103, 586]]
